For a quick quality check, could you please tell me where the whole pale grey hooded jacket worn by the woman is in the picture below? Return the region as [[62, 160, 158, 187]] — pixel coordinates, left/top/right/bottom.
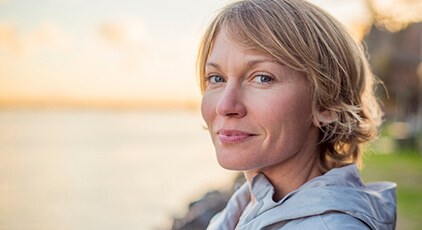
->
[[207, 164, 396, 230]]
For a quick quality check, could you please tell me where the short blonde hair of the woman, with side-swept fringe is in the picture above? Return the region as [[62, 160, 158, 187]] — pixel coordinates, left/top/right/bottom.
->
[[197, 0, 382, 171]]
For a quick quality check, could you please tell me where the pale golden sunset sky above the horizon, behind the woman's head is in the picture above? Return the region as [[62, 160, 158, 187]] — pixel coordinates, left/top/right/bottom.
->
[[0, 0, 371, 107]]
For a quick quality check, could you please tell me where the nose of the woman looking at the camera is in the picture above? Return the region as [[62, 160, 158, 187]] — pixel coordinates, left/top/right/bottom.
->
[[216, 83, 247, 118]]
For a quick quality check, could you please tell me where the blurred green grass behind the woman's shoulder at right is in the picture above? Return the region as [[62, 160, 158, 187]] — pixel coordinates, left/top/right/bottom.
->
[[362, 150, 422, 230]]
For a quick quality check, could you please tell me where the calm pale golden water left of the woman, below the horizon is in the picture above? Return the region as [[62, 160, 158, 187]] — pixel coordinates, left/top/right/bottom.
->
[[0, 110, 234, 230]]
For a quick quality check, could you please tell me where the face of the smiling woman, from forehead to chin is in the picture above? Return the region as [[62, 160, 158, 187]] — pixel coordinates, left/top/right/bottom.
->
[[201, 31, 319, 171]]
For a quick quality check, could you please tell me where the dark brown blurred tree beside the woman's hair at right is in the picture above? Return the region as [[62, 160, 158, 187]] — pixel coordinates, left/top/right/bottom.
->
[[365, 23, 422, 121]]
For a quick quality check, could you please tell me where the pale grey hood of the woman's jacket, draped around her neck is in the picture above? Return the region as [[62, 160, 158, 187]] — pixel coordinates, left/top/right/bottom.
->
[[238, 164, 396, 229]]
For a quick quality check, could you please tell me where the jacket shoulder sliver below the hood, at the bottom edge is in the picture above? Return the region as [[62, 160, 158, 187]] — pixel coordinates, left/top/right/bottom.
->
[[266, 212, 370, 230]]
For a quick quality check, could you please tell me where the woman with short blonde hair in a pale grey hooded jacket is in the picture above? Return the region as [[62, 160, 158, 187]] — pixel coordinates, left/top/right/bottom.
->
[[197, 0, 396, 229]]
